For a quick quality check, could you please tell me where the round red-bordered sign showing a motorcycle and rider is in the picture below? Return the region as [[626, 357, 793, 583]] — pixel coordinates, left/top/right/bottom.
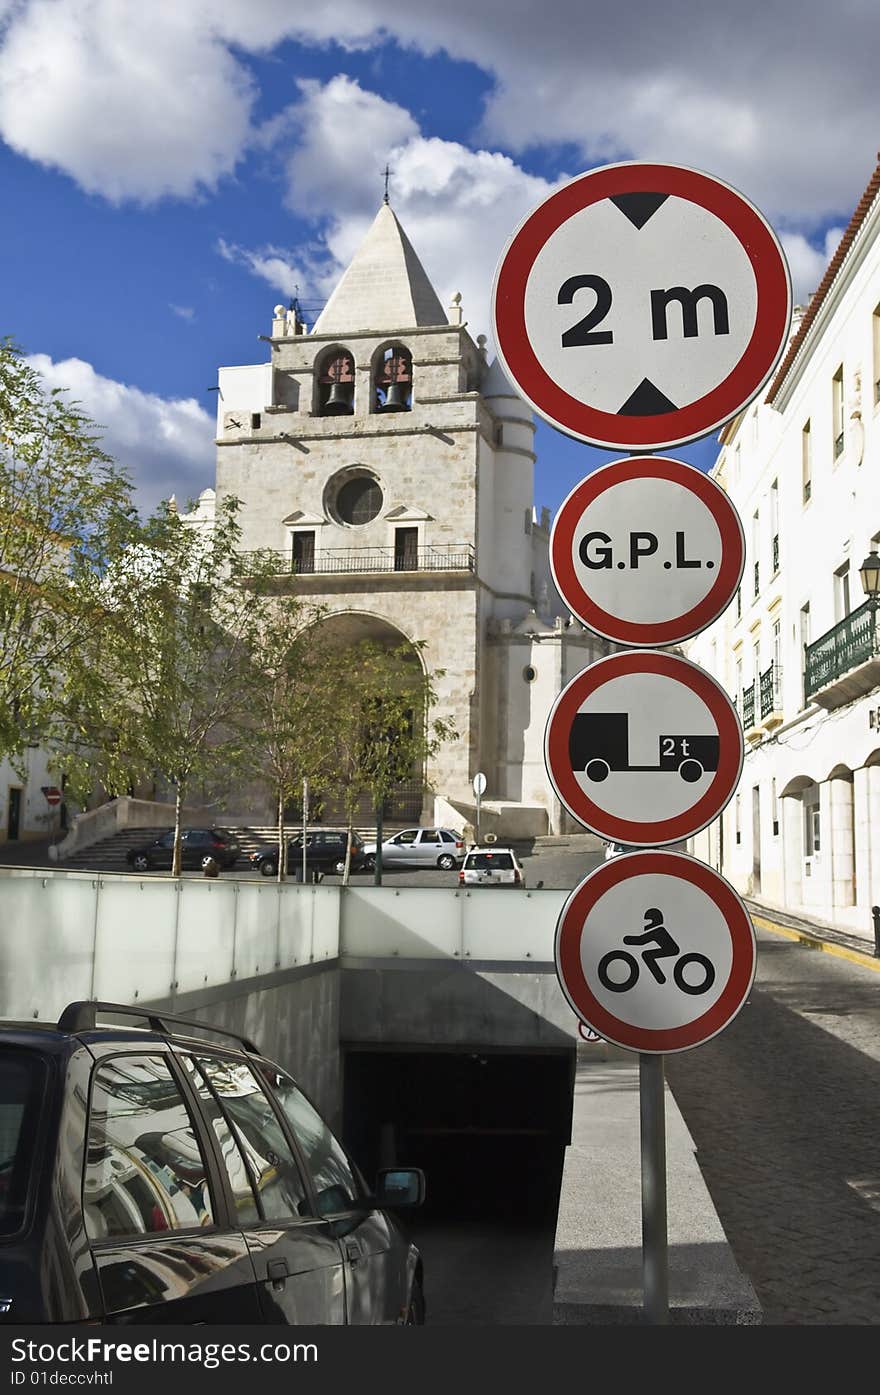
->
[[555, 851, 756, 1053]]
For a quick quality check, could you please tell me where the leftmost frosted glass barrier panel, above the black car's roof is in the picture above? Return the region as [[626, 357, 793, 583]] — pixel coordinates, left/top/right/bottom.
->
[[0, 873, 98, 1021]]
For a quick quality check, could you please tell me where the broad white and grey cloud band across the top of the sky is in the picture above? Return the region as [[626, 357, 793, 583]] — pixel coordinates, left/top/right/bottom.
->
[[0, 0, 880, 230]]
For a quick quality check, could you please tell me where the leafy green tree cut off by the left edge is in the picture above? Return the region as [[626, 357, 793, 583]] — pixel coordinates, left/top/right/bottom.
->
[[0, 339, 135, 766]]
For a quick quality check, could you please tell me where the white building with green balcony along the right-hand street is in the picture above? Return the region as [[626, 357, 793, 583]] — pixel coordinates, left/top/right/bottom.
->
[[688, 155, 880, 935]]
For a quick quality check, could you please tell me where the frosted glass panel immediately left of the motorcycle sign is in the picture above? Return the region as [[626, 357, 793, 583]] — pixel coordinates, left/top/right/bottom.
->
[[462, 886, 569, 964]]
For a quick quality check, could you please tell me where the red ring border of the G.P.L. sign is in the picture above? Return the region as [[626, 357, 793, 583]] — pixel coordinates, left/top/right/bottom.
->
[[549, 455, 746, 647]]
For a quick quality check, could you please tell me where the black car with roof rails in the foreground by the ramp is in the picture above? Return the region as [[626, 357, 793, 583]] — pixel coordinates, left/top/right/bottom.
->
[[0, 1002, 424, 1325]]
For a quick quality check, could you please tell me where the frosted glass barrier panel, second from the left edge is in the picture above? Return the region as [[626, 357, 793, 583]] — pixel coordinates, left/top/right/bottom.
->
[[95, 876, 180, 1003]]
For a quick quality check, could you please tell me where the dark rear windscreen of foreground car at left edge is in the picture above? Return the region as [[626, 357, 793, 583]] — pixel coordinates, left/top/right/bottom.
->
[[0, 1050, 46, 1235]]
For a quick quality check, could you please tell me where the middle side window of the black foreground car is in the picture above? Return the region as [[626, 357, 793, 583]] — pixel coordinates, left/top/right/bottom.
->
[[197, 1056, 310, 1221]]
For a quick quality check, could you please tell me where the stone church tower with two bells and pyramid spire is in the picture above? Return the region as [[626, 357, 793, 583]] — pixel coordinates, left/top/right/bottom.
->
[[216, 202, 605, 831]]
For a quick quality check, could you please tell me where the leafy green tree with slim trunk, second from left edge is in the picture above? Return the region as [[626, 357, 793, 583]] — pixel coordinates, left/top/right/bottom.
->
[[57, 498, 266, 876]]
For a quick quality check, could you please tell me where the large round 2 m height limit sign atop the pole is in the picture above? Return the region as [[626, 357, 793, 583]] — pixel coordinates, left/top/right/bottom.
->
[[492, 162, 791, 451]]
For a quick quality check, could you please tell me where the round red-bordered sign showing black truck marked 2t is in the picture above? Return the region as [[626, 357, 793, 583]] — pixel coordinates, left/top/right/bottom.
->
[[544, 650, 743, 847]]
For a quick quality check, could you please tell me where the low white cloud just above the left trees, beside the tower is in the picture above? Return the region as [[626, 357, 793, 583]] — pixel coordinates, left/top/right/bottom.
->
[[28, 353, 216, 512]]
